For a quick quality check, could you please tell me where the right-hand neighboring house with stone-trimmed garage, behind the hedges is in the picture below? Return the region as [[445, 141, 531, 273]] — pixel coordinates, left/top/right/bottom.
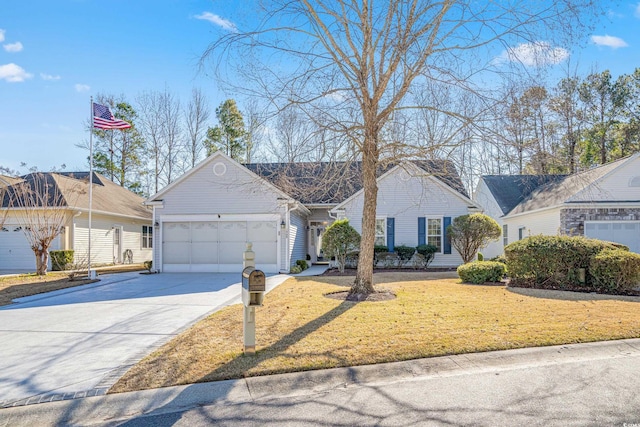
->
[[474, 153, 640, 256]]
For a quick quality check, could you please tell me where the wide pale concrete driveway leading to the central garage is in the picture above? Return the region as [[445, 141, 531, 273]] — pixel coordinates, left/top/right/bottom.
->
[[0, 273, 290, 407]]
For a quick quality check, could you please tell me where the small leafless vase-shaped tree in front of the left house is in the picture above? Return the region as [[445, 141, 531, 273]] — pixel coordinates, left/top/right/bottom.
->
[[7, 172, 84, 276]]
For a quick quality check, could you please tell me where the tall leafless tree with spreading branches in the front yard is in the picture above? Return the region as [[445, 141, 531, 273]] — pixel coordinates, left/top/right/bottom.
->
[[204, 0, 597, 294]]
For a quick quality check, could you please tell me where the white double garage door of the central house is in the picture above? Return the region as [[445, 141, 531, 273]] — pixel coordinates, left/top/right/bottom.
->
[[162, 221, 278, 273]]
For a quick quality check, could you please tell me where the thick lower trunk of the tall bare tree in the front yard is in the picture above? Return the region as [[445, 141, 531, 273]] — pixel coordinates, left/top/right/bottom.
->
[[349, 131, 378, 294]]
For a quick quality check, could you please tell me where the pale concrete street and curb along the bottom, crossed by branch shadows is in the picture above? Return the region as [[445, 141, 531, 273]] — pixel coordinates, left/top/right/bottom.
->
[[0, 339, 640, 426]]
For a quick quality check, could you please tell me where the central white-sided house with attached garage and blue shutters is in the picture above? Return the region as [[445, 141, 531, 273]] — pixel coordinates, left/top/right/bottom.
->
[[147, 152, 478, 272]]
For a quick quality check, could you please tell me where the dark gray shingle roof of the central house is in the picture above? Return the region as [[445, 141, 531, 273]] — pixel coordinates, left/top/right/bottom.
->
[[244, 160, 468, 204]]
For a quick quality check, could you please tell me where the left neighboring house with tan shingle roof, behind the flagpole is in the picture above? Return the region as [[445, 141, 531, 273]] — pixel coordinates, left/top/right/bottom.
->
[[0, 172, 153, 271]]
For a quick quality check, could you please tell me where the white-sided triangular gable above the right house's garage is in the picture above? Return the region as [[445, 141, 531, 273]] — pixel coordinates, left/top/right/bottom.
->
[[569, 156, 640, 202]]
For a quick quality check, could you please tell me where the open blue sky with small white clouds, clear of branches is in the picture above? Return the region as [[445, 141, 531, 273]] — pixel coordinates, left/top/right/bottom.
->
[[0, 0, 640, 171]]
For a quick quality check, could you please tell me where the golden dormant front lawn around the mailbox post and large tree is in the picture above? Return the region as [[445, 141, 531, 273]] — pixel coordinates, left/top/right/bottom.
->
[[110, 273, 640, 393]]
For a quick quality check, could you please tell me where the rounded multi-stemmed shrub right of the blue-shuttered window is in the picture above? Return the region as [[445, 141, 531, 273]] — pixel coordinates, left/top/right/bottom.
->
[[447, 213, 502, 264]]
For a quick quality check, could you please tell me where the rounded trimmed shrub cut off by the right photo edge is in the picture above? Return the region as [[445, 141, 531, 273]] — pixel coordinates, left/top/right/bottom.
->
[[589, 249, 640, 292]]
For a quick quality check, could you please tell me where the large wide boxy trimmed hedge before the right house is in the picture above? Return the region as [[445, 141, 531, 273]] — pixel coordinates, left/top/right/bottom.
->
[[504, 235, 629, 289]]
